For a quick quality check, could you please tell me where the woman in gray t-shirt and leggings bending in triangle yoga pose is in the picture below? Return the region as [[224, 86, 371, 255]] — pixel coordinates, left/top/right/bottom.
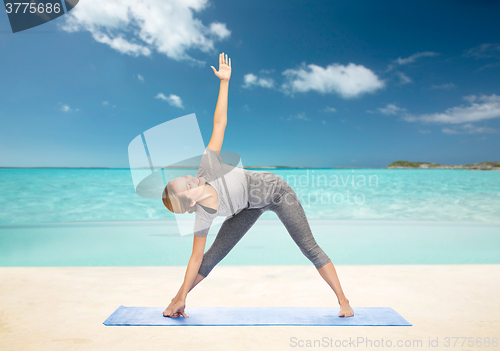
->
[[163, 53, 354, 318]]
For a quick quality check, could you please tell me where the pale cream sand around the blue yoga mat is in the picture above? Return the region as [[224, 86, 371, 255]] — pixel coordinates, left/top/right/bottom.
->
[[0, 265, 500, 351]]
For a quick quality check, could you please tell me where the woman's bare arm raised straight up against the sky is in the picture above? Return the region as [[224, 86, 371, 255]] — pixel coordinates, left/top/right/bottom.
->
[[208, 53, 231, 154]]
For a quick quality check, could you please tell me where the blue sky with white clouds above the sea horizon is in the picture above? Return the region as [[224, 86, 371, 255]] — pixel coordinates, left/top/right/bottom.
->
[[0, 0, 500, 168]]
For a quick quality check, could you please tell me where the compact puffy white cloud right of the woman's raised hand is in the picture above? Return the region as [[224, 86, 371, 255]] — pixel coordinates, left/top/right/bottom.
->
[[282, 63, 385, 99]]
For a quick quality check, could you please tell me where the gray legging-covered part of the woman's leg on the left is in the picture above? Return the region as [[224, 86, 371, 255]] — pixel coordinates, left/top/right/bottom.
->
[[196, 208, 264, 280]]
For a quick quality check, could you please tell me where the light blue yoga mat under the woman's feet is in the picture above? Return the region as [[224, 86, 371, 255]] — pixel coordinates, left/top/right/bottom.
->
[[104, 306, 411, 326]]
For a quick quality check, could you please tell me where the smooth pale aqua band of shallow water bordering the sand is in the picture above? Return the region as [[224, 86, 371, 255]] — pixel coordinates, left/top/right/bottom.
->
[[0, 219, 500, 269]]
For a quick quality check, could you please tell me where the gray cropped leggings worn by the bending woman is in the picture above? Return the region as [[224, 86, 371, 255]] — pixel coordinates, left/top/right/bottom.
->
[[198, 183, 330, 277]]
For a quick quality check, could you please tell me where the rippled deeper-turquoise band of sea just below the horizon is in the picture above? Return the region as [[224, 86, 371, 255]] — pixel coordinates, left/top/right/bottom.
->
[[0, 169, 500, 224]]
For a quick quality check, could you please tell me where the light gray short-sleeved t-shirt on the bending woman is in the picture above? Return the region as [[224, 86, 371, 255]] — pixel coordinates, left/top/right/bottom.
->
[[193, 147, 284, 237]]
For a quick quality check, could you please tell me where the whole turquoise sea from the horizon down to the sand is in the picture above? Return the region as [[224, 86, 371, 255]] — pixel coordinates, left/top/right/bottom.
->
[[0, 169, 500, 266]]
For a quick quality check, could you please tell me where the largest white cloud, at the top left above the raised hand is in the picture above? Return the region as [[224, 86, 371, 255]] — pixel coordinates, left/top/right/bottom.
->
[[60, 0, 231, 63]]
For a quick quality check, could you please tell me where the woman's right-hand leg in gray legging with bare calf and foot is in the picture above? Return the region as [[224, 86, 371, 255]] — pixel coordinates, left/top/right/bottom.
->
[[270, 184, 354, 317]]
